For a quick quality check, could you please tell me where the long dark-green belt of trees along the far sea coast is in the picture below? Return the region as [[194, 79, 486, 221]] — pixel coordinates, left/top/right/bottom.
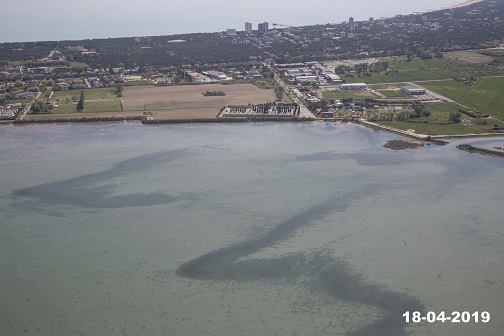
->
[[0, 1, 504, 78]]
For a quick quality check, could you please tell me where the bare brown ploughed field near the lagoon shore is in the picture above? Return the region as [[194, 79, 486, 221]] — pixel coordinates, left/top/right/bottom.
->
[[121, 84, 276, 119]]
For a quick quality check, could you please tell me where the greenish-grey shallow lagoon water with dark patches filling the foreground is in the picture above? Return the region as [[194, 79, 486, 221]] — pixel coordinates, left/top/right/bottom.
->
[[0, 123, 504, 336]]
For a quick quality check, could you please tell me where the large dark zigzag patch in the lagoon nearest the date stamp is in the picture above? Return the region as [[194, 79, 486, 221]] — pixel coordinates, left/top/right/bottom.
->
[[176, 185, 425, 336]]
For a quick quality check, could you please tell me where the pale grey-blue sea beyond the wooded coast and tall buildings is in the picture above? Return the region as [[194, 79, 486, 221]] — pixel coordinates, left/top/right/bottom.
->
[[0, 0, 462, 42]]
